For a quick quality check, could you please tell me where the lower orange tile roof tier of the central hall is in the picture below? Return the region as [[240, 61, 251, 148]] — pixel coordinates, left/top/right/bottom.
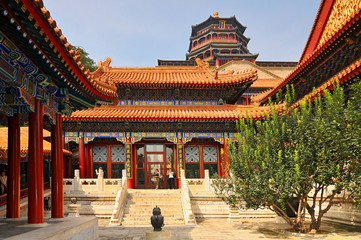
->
[[63, 105, 278, 121]]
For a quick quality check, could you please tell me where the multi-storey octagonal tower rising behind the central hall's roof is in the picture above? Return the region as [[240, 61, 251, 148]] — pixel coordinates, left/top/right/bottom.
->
[[186, 12, 258, 66]]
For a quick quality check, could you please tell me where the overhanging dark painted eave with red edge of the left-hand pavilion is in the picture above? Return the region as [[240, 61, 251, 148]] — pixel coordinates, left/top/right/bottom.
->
[[0, 0, 118, 110]]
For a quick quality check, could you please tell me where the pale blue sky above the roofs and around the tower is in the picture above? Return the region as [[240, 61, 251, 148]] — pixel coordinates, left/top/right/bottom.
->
[[43, 0, 321, 67]]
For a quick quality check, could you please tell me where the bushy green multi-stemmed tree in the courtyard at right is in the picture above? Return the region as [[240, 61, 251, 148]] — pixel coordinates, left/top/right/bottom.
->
[[214, 83, 361, 232]]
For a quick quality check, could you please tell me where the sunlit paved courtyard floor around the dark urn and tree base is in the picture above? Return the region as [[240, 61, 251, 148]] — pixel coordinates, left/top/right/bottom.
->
[[99, 218, 361, 240]]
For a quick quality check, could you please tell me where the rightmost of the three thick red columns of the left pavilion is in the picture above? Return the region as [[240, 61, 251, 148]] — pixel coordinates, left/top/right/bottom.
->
[[51, 113, 64, 218]]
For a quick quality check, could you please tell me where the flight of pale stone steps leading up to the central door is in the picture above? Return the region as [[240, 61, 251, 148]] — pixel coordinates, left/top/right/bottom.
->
[[122, 189, 185, 226]]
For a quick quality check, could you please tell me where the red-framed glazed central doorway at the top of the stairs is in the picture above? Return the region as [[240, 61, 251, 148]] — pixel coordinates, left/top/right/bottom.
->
[[135, 143, 174, 188]]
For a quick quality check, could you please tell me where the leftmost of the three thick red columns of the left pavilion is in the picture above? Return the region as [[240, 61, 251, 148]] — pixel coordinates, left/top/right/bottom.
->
[[6, 114, 20, 218]]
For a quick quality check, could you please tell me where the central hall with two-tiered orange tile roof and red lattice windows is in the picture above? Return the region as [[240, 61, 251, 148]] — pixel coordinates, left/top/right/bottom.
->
[[63, 59, 262, 188]]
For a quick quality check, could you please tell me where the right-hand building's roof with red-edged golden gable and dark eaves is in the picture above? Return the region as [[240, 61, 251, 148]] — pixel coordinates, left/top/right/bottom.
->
[[252, 0, 361, 105]]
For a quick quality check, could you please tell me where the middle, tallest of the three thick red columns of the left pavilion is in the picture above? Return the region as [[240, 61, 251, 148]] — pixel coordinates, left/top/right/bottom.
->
[[28, 99, 44, 223]]
